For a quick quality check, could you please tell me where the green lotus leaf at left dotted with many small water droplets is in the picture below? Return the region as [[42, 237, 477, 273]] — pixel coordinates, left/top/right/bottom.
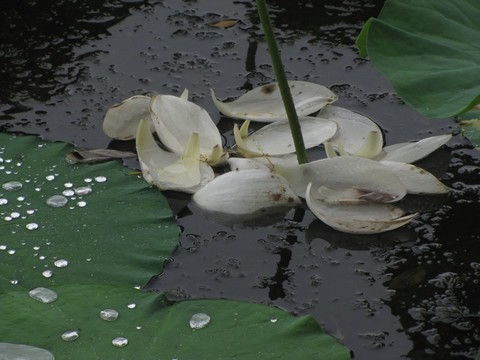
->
[[0, 134, 178, 291]]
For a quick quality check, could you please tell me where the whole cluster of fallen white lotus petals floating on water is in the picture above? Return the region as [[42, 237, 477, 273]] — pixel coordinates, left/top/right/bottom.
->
[[103, 81, 451, 234]]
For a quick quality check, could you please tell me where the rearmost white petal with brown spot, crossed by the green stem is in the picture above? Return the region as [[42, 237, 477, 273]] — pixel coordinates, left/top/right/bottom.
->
[[211, 81, 337, 122]]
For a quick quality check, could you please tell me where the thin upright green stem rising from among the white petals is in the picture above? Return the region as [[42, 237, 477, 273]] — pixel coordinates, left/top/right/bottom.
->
[[256, 0, 308, 164]]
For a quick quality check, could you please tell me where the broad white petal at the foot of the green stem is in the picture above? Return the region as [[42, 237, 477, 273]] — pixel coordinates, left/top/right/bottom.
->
[[275, 156, 406, 202]]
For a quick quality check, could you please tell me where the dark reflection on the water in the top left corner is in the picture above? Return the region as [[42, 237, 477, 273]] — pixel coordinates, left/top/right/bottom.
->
[[0, 0, 152, 115]]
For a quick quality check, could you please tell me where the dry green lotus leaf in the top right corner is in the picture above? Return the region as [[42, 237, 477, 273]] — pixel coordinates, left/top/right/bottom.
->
[[357, 0, 480, 118]]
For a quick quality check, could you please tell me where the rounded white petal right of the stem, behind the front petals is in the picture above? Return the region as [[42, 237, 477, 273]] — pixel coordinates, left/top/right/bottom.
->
[[317, 105, 383, 158]]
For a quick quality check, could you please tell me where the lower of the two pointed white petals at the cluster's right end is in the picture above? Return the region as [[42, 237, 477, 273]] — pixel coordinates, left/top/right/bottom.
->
[[381, 161, 448, 194]]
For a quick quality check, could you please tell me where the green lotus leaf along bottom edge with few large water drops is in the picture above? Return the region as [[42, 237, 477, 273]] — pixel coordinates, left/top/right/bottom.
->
[[0, 284, 350, 360]]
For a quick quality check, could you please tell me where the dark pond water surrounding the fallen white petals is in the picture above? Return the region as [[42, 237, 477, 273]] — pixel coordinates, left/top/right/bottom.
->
[[0, 0, 480, 360]]
